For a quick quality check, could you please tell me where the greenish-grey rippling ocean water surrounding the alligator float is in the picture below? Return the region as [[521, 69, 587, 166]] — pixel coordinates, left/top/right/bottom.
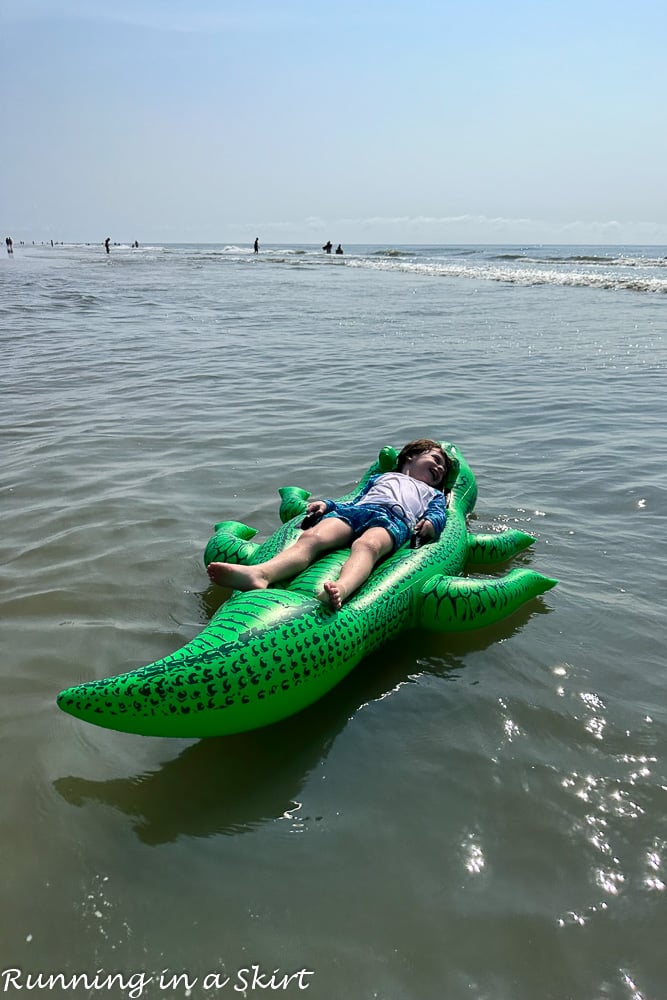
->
[[0, 243, 667, 1000]]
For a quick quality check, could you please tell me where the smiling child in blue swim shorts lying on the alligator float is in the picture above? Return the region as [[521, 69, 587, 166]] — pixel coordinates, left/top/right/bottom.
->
[[208, 438, 450, 611]]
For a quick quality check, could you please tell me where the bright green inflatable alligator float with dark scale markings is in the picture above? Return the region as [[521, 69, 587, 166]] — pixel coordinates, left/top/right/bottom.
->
[[58, 443, 556, 737]]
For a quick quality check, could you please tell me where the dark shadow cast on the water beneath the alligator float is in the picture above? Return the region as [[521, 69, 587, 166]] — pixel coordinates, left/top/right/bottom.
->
[[54, 600, 549, 844]]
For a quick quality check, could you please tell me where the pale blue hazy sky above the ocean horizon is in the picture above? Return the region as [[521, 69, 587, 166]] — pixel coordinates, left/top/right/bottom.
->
[[0, 0, 667, 246]]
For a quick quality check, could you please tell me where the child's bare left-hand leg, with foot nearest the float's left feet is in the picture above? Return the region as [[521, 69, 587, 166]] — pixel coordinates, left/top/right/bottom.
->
[[208, 517, 352, 590]]
